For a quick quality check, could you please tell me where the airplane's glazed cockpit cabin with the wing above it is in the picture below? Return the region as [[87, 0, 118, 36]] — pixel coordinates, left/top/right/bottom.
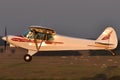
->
[[23, 26, 56, 40]]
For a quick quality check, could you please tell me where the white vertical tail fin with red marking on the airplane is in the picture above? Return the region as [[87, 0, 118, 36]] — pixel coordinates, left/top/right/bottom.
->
[[96, 27, 118, 49]]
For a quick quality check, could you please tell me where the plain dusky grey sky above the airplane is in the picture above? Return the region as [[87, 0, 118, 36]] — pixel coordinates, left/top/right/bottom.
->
[[0, 0, 120, 39]]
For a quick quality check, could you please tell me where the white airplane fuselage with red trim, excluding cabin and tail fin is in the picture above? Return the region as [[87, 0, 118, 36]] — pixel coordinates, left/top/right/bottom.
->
[[3, 35, 112, 51]]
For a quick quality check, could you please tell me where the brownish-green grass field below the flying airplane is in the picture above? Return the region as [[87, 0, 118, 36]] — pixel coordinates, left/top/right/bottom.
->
[[0, 48, 120, 80]]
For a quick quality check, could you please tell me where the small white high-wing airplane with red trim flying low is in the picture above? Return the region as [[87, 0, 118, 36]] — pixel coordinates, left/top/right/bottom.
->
[[2, 26, 118, 62]]
